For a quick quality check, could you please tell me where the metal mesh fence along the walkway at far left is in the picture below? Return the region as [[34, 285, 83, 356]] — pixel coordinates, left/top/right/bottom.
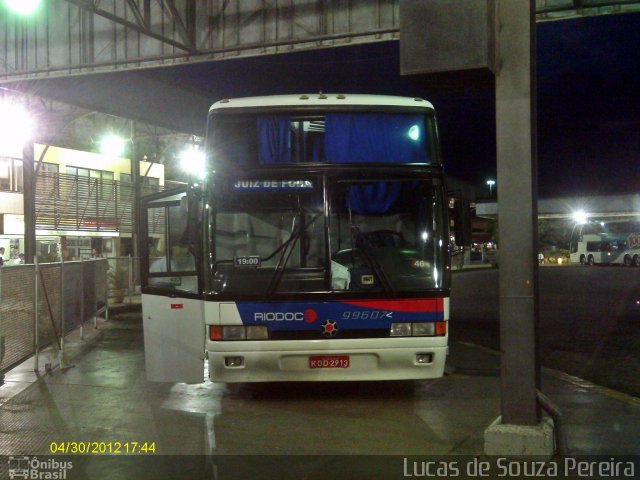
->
[[0, 259, 109, 383]]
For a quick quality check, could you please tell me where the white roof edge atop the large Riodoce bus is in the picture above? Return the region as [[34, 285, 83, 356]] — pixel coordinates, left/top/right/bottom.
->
[[209, 93, 433, 111]]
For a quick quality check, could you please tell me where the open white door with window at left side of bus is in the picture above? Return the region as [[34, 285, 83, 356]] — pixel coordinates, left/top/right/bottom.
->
[[140, 190, 204, 383]]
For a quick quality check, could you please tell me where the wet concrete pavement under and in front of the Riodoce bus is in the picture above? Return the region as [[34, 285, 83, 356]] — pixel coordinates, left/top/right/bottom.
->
[[0, 313, 640, 478]]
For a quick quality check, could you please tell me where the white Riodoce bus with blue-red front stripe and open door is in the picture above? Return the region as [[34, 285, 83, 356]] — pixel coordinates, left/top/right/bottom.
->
[[140, 94, 451, 382]]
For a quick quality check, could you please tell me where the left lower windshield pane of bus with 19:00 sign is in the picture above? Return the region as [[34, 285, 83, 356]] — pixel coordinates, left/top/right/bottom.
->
[[213, 180, 327, 295]]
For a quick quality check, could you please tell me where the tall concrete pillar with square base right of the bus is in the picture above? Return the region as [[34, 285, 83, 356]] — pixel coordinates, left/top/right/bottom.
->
[[485, 0, 553, 455]]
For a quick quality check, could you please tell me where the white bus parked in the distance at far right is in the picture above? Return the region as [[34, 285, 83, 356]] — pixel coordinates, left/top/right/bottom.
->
[[570, 221, 640, 267]]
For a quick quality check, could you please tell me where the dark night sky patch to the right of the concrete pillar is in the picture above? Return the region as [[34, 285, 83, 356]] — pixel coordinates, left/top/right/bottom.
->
[[538, 14, 640, 198]]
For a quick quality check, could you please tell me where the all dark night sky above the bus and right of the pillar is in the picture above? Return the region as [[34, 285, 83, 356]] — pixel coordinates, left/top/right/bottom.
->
[[155, 14, 640, 197]]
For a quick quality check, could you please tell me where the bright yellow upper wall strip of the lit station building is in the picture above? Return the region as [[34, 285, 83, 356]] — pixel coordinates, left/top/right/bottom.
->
[[34, 143, 164, 185]]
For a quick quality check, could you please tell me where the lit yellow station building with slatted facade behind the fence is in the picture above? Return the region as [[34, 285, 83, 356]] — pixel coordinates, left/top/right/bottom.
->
[[0, 144, 165, 261]]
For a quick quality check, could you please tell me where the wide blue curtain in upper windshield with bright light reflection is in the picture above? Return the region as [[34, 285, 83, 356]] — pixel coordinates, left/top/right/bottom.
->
[[324, 113, 429, 163]]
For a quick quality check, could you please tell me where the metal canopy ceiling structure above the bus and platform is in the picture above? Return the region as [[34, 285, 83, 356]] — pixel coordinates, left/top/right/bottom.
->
[[0, 0, 640, 172]]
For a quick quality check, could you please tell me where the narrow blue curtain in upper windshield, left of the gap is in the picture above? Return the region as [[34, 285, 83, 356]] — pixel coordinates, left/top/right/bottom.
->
[[258, 115, 291, 165]]
